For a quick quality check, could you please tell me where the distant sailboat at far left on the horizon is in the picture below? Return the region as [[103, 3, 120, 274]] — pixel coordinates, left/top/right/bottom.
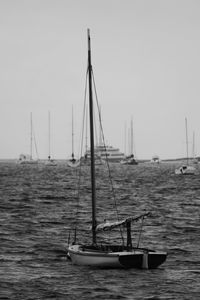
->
[[18, 112, 38, 165]]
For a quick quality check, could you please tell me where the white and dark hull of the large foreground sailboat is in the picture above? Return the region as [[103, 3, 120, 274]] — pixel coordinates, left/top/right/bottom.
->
[[68, 245, 167, 269]]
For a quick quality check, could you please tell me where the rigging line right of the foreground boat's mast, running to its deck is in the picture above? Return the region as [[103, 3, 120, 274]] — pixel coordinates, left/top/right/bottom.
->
[[92, 70, 124, 244]]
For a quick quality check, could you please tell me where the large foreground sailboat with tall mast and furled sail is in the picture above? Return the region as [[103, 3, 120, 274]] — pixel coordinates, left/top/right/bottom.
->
[[67, 29, 167, 269]]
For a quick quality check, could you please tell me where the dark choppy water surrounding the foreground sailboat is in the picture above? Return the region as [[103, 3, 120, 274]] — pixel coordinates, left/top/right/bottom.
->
[[0, 162, 200, 300]]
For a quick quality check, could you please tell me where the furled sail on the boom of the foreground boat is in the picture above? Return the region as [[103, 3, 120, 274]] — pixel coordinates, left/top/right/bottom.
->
[[96, 212, 150, 231]]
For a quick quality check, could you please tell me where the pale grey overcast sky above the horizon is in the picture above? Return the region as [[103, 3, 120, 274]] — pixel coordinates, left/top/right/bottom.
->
[[0, 0, 200, 159]]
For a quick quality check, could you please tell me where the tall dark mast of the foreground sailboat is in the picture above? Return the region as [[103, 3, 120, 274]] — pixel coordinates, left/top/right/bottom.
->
[[88, 29, 96, 244]]
